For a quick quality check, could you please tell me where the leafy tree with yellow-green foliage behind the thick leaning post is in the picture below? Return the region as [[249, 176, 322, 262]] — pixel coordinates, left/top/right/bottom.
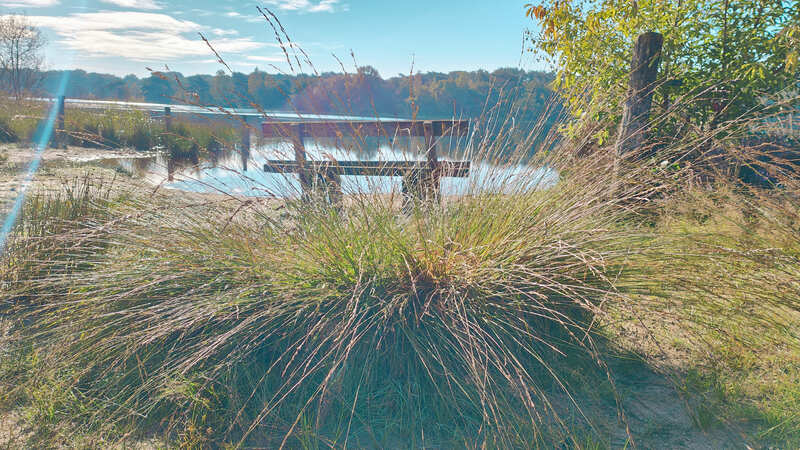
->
[[526, 0, 800, 141]]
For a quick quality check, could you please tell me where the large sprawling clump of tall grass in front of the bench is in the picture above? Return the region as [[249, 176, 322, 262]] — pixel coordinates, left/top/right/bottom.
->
[[0, 94, 676, 447]]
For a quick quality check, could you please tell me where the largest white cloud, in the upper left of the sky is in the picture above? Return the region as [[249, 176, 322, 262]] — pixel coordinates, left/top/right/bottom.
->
[[13, 11, 265, 62]]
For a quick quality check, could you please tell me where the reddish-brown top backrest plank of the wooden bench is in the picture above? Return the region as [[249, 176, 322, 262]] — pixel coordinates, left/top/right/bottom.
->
[[261, 120, 469, 138]]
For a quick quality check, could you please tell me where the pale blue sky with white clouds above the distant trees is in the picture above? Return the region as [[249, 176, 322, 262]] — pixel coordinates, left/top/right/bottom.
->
[[0, 0, 539, 77]]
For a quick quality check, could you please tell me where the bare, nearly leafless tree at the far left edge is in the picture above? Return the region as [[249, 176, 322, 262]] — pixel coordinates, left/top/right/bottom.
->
[[0, 15, 46, 99]]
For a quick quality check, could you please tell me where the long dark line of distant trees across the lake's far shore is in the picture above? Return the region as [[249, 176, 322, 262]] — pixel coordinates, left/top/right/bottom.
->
[[41, 66, 553, 121]]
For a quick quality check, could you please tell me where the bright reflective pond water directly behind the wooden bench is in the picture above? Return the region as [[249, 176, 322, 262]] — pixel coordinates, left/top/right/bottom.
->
[[95, 136, 558, 197]]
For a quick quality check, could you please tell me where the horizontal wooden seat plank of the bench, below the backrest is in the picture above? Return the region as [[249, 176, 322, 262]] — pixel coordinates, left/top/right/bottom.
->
[[264, 159, 471, 178]]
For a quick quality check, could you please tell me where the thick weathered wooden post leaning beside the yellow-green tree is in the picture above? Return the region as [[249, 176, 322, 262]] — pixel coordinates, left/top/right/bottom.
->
[[616, 31, 664, 156]]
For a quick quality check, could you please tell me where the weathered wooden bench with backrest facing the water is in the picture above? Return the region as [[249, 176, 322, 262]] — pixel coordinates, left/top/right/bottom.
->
[[261, 120, 470, 204]]
